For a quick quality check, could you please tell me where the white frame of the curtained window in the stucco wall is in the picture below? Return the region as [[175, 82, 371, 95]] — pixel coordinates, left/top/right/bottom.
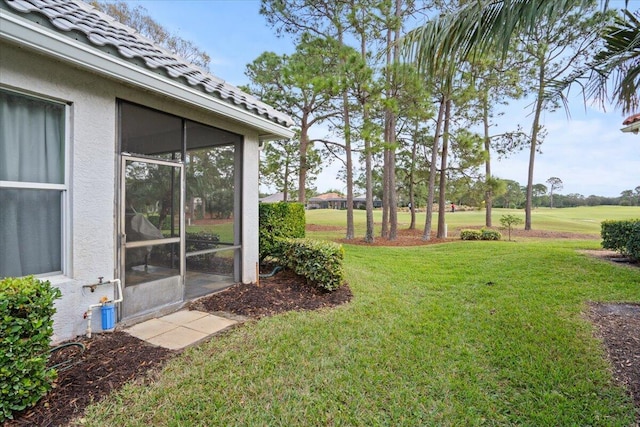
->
[[0, 85, 72, 279]]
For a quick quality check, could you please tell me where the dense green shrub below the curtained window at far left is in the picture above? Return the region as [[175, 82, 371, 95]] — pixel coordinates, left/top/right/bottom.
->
[[0, 276, 60, 422]]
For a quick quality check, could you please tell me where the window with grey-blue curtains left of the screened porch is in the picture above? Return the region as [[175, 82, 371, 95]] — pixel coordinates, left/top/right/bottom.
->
[[0, 90, 67, 278]]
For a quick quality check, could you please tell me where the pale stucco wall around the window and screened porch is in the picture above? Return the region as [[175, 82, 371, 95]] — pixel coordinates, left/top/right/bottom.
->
[[0, 43, 258, 342]]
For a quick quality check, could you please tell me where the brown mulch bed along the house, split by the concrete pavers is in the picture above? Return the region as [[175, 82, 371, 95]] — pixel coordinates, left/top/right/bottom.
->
[[5, 270, 352, 427]]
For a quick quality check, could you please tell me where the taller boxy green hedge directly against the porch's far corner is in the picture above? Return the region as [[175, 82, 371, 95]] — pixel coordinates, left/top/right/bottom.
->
[[258, 202, 305, 262]]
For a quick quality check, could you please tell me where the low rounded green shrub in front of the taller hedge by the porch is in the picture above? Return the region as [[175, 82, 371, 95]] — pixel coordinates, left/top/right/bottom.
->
[[277, 239, 344, 291]]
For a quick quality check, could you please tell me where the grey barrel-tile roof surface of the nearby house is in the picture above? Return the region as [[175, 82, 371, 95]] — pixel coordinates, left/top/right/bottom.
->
[[0, 0, 293, 127]]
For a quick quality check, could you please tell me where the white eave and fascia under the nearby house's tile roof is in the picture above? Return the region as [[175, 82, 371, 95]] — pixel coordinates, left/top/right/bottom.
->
[[0, 9, 295, 140]]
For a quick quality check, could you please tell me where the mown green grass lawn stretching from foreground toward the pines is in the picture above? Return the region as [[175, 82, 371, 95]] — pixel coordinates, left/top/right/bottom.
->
[[83, 209, 640, 426]]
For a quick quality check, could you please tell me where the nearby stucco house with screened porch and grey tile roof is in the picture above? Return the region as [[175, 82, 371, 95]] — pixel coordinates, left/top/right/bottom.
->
[[0, 0, 294, 341]]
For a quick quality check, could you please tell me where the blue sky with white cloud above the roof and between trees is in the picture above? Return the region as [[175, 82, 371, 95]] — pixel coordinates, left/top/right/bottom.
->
[[130, 0, 640, 196]]
